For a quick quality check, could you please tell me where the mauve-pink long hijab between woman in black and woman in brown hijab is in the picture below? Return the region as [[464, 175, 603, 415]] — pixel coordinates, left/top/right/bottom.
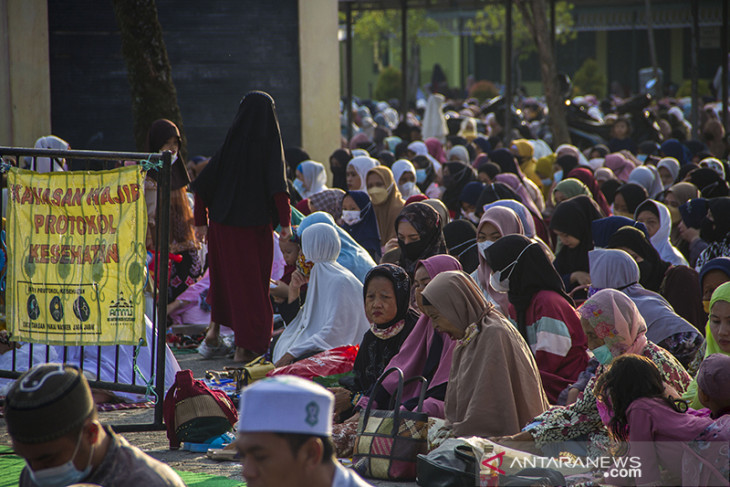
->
[[378, 254, 461, 418]]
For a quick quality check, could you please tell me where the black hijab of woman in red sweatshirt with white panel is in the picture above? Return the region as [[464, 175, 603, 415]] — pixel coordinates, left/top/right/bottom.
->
[[485, 235, 575, 340]]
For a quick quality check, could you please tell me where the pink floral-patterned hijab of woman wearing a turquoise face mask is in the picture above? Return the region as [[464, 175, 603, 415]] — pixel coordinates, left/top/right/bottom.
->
[[578, 289, 647, 357]]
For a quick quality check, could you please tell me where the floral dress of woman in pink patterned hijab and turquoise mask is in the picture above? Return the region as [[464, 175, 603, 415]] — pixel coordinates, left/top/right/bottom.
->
[[529, 342, 692, 454]]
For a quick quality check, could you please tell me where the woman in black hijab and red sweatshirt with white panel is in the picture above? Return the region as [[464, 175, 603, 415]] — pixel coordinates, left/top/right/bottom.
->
[[485, 235, 588, 402]]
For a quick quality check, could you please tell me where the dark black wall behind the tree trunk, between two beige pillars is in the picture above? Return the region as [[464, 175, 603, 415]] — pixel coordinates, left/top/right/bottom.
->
[[46, 0, 302, 155]]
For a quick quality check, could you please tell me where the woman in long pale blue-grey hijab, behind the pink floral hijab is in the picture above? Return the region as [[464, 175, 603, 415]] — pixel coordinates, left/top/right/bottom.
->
[[589, 249, 704, 367]]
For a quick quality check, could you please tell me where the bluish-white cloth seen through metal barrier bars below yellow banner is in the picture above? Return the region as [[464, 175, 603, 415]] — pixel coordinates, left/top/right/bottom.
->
[[55, 316, 180, 402]]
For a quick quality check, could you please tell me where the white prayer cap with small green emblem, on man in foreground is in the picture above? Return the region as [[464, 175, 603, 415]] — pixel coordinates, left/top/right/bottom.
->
[[238, 375, 334, 436]]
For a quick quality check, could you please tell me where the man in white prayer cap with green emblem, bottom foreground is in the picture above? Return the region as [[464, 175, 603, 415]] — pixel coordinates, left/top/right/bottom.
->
[[236, 376, 370, 487]]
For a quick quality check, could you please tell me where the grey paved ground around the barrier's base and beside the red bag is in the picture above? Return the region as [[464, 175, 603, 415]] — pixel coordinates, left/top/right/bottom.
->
[[0, 353, 415, 487]]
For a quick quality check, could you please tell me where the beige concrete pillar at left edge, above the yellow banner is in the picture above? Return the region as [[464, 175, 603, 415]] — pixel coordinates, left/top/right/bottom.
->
[[0, 0, 51, 147]]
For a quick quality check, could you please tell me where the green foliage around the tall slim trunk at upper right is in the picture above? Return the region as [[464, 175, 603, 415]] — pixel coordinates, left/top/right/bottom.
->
[[466, 0, 576, 60]]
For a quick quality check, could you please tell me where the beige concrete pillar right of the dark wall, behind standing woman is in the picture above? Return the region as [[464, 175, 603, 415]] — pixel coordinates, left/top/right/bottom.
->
[[299, 0, 340, 182]]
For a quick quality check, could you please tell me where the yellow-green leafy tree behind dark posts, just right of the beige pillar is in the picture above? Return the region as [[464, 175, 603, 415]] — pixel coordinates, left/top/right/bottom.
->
[[353, 9, 440, 102]]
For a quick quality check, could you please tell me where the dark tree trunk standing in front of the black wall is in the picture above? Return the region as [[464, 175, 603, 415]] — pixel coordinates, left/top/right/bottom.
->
[[112, 0, 186, 156]]
